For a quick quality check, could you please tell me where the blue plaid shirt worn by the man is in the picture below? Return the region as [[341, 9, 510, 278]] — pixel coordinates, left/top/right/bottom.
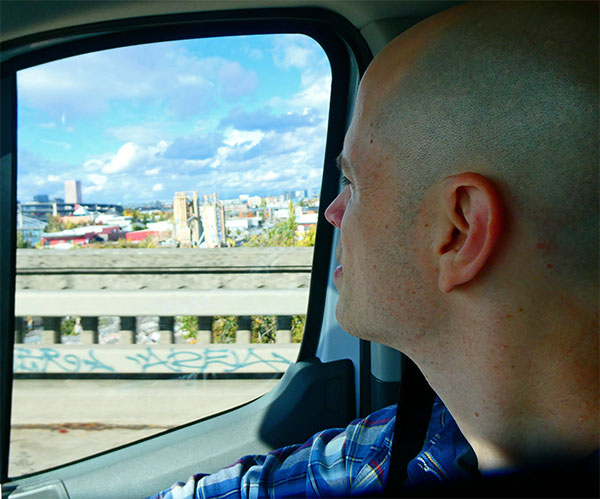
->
[[153, 399, 476, 499]]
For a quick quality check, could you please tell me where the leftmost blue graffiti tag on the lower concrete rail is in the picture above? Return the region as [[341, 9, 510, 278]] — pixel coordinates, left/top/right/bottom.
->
[[14, 347, 115, 373]]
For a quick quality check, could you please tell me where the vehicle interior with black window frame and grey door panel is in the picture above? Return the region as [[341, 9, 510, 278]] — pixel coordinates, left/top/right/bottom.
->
[[0, 0, 552, 499]]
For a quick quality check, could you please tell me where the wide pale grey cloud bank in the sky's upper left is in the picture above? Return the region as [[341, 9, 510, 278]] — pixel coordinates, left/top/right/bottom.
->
[[18, 42, 259, 119]]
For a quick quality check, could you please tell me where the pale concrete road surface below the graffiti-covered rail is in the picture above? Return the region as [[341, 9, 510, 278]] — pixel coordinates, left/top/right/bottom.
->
[[9, 378, 277, 477]]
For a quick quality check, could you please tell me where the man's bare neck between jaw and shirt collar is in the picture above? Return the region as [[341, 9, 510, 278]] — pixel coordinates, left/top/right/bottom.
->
[[416, 312, 599, 471]]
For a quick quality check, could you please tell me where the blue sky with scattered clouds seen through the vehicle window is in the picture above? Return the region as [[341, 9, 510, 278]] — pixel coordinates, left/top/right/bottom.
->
[[17, 35, 331, 205]]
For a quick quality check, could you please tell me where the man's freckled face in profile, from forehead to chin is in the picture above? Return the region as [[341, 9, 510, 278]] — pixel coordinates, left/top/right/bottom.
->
[[326, 108, 434, 345]]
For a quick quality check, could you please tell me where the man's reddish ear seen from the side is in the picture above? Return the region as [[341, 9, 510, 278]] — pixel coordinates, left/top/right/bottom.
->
[[435, 173, 503, 293]]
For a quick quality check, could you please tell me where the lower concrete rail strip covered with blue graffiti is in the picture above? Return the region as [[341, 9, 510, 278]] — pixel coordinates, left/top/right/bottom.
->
[[14, 345, 297, 373]]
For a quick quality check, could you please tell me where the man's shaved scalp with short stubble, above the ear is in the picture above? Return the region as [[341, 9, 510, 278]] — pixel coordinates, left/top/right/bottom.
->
[[362, 2, 599, 284]]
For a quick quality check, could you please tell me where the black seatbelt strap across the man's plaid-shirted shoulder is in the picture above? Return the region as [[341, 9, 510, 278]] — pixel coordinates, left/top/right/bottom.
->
[[386, 357, 435, 497]]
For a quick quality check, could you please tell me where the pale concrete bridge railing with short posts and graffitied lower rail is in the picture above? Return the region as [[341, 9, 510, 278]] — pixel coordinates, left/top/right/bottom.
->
[[15, 288, 308, 374]]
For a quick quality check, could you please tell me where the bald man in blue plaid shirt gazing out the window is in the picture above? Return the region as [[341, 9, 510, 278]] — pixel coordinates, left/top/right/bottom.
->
[[152, 2, 600, 497]]
